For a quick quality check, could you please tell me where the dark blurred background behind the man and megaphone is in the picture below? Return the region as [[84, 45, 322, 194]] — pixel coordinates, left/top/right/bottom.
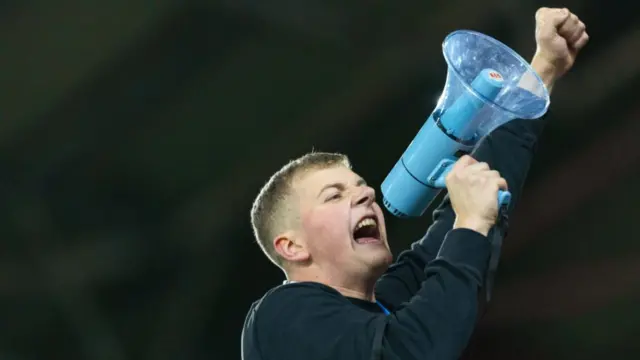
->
[[0, 0, 640, 360]]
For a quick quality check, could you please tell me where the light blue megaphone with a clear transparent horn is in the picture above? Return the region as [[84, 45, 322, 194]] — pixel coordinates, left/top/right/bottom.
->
[[381, 30, 549, 217]]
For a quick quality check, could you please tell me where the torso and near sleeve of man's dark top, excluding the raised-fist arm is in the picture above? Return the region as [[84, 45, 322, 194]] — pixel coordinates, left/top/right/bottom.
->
[[243, 229, 489, 360]]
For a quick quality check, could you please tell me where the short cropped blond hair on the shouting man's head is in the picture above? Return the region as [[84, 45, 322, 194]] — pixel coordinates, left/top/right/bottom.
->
[[251, 152, 351, 268]]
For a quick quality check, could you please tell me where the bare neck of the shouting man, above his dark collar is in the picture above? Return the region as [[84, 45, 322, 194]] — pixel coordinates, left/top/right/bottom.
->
[[287, 271, 376, 302]]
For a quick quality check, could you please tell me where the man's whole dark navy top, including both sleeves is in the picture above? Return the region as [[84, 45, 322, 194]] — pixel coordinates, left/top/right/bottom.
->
[[242, 116, 545, 360]]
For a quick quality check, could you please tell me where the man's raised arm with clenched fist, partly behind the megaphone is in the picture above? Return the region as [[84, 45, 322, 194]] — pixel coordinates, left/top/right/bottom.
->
[[376, 4, 589, 307]]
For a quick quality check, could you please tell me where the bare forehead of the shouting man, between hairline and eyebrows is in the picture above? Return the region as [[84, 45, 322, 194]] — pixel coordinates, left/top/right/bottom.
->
[[293, 166, 362, 198]]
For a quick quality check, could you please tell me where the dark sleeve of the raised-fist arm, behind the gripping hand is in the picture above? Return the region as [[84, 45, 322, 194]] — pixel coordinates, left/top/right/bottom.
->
[[376, 118, 546, 308]]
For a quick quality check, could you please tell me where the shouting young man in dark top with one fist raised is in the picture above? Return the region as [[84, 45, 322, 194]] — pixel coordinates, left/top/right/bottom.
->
[[242, 8, 588, 360]]
